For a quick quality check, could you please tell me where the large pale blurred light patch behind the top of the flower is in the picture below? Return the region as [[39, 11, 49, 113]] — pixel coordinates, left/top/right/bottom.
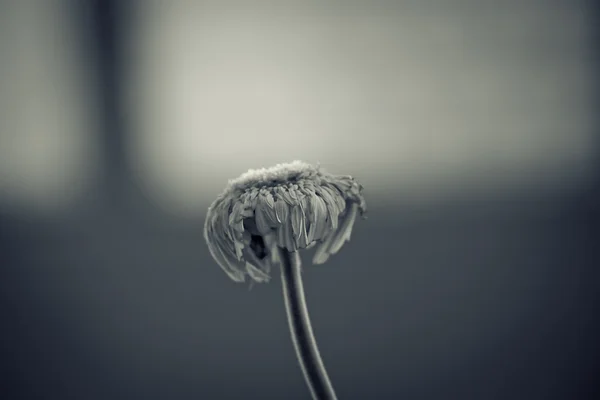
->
[[125, 2, 597, 216]]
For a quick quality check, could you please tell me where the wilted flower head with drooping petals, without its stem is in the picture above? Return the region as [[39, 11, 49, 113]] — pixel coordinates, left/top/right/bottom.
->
[[204, 161, 367, 282]]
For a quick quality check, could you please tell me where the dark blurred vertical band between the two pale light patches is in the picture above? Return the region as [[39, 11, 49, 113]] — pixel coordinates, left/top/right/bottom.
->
[[68, 0, 134, 207]]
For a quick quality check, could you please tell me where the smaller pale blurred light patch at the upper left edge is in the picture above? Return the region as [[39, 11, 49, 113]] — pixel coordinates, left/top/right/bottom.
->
[[0, 1, 97, 211]]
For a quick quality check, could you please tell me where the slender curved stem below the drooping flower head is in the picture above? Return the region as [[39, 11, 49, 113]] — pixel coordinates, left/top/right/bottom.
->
[[280, 249, 337, 400]]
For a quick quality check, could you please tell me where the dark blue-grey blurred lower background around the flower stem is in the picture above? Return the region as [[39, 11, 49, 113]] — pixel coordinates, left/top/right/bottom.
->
[[1, 192, 600, 399]]
